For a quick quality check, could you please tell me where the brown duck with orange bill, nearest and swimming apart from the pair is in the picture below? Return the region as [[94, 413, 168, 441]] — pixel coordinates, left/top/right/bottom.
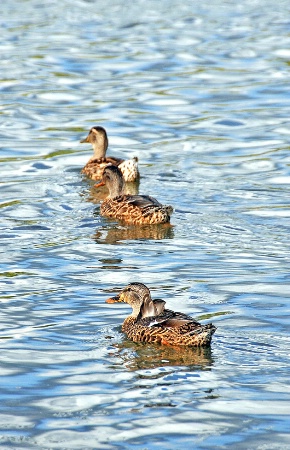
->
[[106, 283, 216, 347]]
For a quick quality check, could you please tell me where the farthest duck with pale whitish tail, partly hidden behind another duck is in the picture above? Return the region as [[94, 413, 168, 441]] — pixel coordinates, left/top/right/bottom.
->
[[81, 127, 139, 182]]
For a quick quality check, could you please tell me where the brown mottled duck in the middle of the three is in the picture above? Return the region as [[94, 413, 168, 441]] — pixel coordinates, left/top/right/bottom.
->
[[95, 166, 173, 225]]
